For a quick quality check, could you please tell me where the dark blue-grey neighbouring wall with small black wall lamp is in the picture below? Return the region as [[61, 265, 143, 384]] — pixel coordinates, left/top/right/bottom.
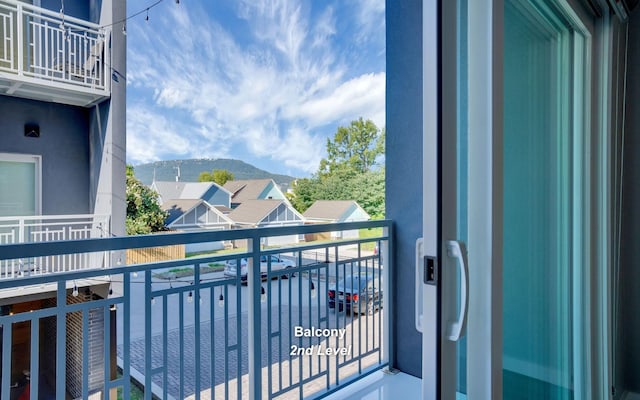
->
[[0, 96, 90, 215]]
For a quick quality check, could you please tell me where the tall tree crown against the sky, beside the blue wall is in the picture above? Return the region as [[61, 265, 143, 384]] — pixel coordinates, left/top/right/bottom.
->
[[319, 118, 385, 176]]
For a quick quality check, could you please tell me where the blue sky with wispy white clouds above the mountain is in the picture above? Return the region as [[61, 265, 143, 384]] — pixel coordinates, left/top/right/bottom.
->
[[125, 0, 385, 176]]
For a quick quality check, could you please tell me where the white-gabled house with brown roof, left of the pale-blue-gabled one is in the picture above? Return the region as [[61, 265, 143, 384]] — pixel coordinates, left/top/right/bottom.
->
[[227, 200, 304, 246]]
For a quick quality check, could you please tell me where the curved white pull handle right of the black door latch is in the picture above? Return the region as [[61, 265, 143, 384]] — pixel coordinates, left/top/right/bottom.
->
[[445, 240, 469, 342]]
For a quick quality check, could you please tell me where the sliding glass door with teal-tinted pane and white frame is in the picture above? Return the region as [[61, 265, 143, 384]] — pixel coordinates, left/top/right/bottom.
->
[[419, 0, 606, 400]]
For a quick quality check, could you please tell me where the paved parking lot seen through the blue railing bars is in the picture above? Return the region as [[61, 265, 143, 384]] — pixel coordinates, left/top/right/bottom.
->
[[117, 250, 382, 398]]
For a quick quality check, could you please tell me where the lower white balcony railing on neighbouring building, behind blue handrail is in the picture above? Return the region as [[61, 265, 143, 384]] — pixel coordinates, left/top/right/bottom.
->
[[0, 215, 110, 279]]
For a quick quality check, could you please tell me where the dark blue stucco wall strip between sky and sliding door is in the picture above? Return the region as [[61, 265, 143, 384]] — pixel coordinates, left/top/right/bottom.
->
[[386, 0, 422, 376]]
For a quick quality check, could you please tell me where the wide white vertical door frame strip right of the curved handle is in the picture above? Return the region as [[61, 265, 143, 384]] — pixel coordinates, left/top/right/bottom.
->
[[467, 0, 504, 400]]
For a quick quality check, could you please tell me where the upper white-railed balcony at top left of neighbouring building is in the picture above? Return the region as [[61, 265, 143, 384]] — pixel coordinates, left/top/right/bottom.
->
[[0, 0, 111, 107]]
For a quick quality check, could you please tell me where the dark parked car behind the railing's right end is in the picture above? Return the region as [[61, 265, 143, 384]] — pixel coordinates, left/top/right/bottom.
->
[[327, 272, 382, 314]]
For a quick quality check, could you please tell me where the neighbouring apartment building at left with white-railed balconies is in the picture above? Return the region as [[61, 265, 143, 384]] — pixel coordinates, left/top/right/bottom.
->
[[0, 0, 126, 398]]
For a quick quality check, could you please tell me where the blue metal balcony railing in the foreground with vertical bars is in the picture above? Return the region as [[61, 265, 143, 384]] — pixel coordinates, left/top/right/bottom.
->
[[0, 221, 393, 399]]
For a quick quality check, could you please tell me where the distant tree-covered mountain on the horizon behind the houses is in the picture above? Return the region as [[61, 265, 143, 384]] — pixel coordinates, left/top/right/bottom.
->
[[133, 158, 296, 191]]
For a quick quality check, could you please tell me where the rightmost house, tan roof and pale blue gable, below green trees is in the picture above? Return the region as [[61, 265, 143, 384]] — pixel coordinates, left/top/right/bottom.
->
[[302, 200, 370, 241]]
